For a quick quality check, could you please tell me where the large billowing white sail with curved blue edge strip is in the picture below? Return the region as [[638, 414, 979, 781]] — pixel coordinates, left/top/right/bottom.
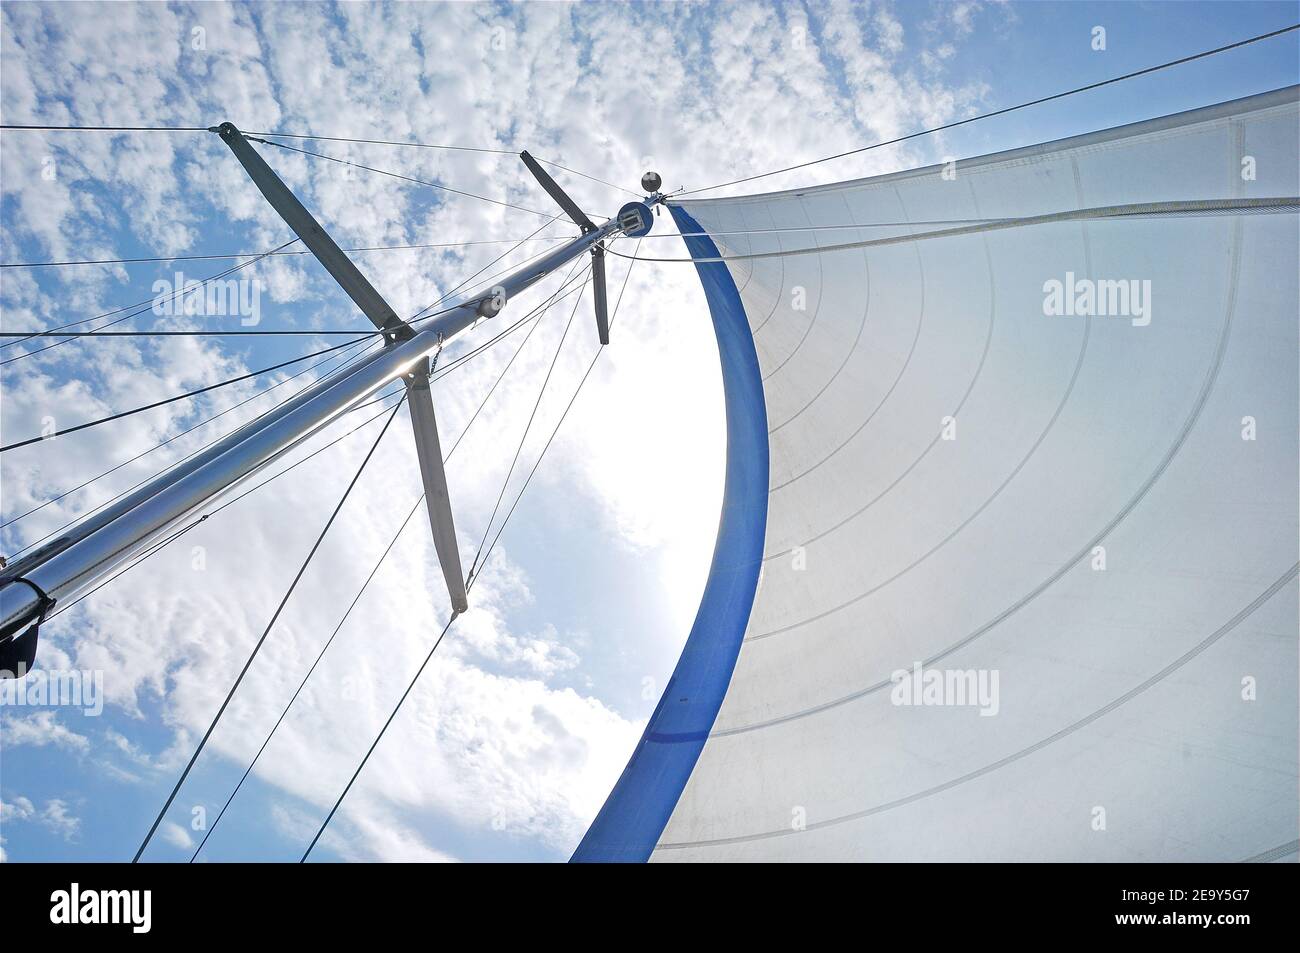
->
[[575, 87, 1300, 861]]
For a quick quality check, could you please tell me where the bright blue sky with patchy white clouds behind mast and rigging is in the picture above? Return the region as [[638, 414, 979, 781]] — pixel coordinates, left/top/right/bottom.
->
[[0, 1, 1295, 861]]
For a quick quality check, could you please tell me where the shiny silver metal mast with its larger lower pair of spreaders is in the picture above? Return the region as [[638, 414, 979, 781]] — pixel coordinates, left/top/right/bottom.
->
[[0, 122, 663, 673]]
